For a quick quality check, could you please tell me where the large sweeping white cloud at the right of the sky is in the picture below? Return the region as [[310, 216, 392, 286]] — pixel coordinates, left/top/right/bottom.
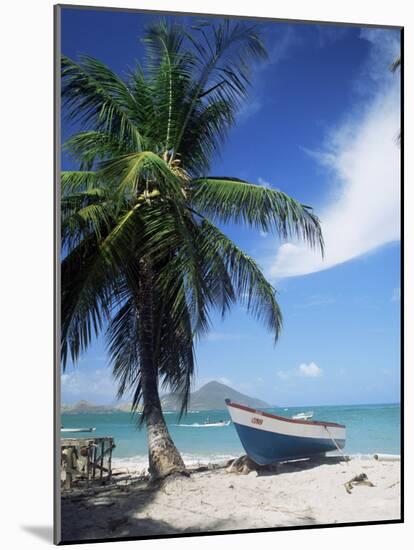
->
[[268, 28, 400, 279]]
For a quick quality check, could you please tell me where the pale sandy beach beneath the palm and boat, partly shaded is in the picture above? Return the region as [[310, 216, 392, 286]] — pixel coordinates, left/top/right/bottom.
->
[[62, 457, 400, 541]]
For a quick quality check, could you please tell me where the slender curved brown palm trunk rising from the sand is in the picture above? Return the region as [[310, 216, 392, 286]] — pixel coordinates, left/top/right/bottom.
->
[[137, 261, 185, 479]]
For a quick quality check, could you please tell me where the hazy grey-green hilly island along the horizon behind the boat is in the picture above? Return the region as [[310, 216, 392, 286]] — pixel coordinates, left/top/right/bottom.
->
[[61, 381, 271, 414]]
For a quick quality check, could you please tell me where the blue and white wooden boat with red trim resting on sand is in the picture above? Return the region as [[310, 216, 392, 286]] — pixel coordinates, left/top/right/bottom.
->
[[226, 399, 346, 465]]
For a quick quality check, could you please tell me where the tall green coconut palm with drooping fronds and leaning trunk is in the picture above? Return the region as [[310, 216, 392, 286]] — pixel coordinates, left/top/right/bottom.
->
[[61, 21, 323, 478]]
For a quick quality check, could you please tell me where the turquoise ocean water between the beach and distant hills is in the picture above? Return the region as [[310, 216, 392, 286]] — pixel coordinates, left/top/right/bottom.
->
[[61, 404, 400, 466]]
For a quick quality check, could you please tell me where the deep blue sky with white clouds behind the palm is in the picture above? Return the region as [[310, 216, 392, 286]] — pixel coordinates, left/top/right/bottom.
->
[[62, 9, 400, 406]]
